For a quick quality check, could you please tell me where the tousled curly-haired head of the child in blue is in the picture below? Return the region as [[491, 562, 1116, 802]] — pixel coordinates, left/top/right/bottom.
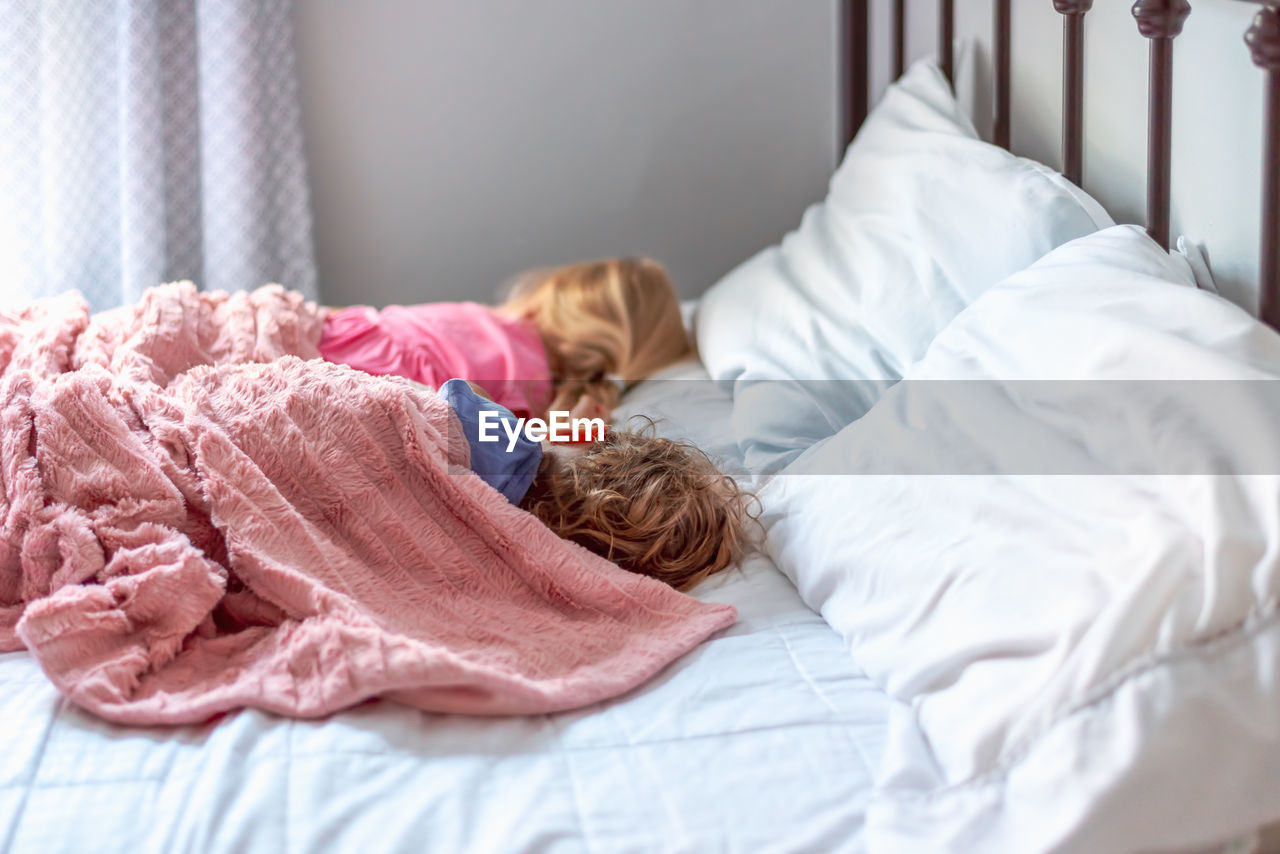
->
[[520, 431, 749, 590]]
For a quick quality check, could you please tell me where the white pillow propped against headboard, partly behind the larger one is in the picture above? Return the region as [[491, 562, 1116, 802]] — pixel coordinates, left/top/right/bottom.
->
[[696, 63, 1112, 469]]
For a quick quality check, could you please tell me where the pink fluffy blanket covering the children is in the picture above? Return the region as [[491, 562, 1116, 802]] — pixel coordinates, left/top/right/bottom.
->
[[0, 284, 735, 723]]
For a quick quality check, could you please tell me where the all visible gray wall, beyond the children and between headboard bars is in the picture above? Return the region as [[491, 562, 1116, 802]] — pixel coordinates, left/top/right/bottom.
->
[[296, 0, 1263, 313]]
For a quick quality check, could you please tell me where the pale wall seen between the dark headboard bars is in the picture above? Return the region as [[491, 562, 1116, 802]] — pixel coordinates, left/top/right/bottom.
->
[[872, 0, 1265, 311]]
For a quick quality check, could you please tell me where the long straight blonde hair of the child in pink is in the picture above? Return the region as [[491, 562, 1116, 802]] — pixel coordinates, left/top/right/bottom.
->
[[500, 259, 694, 410]]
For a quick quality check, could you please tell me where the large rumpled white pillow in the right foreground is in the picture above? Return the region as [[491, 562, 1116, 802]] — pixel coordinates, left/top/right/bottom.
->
[[760, 227, 1280, 854]]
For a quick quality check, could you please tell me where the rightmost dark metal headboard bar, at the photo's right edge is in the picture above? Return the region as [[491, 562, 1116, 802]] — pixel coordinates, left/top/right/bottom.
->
[[1245, 5, 1280, 329]]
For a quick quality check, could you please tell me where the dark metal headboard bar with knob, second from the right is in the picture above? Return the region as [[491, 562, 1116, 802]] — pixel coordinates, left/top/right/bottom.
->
[[1133, 0, 1192, 250]]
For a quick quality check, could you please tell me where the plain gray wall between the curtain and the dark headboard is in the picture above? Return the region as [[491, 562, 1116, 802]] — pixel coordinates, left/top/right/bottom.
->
[[294, 0, 837, 305]]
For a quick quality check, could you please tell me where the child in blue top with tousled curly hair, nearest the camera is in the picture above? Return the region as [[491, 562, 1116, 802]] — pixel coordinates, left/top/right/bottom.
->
[[440, 379, 748, 590]]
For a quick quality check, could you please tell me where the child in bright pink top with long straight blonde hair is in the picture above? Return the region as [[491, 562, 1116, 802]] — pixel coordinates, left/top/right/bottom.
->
[[319, 259, 694, 417]]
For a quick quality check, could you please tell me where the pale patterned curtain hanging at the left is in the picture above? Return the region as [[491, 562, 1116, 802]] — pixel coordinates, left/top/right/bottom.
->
[[0, 0, 316, 309]]
